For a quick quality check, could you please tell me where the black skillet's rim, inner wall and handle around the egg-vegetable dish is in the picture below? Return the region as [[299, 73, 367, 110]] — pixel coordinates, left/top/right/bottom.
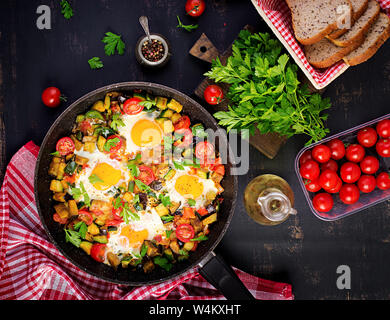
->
[[34, 82, 253, 299]]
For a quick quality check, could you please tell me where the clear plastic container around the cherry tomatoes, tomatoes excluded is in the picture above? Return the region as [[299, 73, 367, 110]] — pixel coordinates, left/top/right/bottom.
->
[[295, 114, 390, 221]]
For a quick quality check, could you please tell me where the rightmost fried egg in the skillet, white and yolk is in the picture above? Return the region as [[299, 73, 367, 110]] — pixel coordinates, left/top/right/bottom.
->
[[165, 168, 218, 209]]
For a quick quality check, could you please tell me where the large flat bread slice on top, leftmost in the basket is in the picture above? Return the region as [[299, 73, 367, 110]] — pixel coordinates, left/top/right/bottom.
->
[[286, 0, 352, 45]]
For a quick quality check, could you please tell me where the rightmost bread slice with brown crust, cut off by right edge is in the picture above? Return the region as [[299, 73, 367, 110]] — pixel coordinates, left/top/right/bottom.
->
[[343, 13, 390, 66]]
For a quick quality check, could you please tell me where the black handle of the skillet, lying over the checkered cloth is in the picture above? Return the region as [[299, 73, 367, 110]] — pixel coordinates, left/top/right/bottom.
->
[[199, 252, 255, 300]]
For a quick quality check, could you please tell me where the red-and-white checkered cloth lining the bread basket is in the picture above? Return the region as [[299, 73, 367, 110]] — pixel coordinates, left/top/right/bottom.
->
[[257, 0, 390, 88]]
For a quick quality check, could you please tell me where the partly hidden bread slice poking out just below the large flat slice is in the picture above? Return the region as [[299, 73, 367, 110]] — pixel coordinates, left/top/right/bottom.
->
[[304, 37, 364, 69]]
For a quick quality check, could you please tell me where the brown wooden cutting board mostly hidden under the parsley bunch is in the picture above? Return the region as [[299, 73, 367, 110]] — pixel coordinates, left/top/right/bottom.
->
[[190, 26, 287, 159]]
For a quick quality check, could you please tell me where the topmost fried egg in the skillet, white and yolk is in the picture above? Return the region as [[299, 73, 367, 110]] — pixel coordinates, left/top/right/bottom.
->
[[119, 112, 163, 154]]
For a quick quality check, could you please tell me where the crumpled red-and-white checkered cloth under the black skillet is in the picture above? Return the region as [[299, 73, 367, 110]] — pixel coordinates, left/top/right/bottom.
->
[[0, 142, 294, 300]]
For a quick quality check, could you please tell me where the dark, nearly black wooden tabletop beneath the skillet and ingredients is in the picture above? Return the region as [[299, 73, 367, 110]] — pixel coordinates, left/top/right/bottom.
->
[[0, 0, 390, 299]]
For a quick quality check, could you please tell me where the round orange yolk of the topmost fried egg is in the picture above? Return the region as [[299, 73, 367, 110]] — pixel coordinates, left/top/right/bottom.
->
[[131, 119, 162, 147]]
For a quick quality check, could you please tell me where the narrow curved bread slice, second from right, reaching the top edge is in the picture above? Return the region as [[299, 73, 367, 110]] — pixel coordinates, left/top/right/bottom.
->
[[331, 0, 381, 47]]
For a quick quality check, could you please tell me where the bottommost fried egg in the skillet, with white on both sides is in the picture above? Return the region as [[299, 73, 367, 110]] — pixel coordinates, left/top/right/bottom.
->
[[107, 209, 166, 255]]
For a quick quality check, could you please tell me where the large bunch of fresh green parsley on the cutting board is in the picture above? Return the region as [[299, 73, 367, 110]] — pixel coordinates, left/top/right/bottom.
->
[[205, 30, 330, 144]]
